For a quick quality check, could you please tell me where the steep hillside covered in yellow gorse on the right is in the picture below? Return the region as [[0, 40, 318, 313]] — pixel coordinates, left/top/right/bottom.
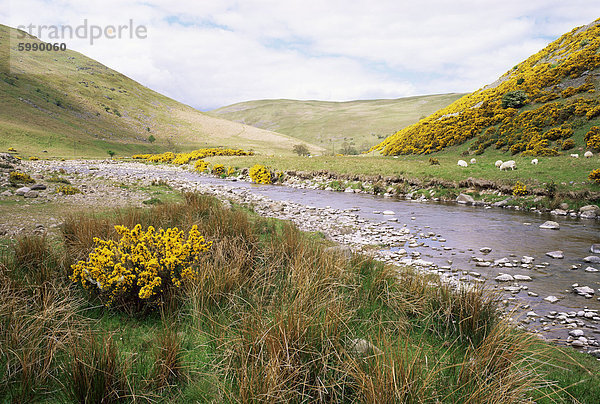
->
[[377, 20, 600, 156]]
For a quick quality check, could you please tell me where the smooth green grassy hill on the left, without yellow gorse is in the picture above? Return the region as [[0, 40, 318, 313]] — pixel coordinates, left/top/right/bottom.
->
[[0, 25, 319, 157]]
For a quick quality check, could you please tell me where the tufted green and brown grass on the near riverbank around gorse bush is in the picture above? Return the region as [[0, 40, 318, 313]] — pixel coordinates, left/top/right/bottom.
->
[[0, 194, 600, 403]]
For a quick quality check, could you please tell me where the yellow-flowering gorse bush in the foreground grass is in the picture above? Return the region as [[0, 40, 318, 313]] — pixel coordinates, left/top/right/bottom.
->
[[71, 224, 212, 307]]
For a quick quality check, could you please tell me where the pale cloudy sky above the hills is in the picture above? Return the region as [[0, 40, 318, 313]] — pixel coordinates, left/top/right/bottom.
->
[[0, 0, 600, 110]]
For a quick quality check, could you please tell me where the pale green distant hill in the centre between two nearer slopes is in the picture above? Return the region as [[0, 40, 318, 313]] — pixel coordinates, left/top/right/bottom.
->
[[210, 94, 462, 151]]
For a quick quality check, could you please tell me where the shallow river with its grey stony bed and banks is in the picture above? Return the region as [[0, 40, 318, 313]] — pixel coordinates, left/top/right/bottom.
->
[[0, 156, 600, 357]]
